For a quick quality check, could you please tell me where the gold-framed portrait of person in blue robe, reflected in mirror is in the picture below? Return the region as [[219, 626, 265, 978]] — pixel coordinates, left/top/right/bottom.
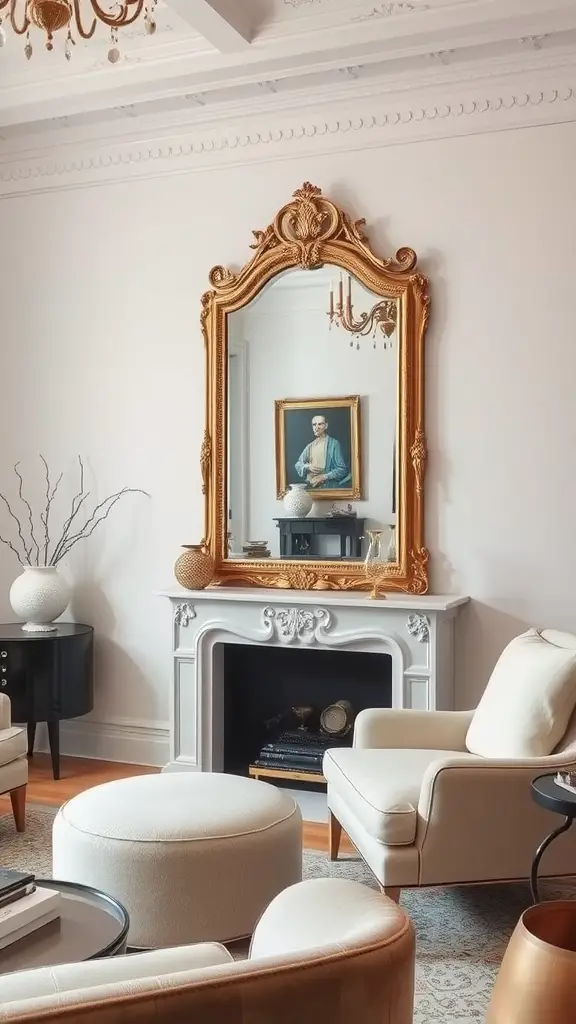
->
[[276, 394, 362, 501]]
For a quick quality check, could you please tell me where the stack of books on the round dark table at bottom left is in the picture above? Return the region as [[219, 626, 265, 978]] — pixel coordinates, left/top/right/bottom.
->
[[0, 867, 61, 949]]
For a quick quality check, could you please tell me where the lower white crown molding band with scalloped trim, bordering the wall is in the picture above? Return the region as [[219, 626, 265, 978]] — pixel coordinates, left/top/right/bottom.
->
[[0, 67, 576, 199]]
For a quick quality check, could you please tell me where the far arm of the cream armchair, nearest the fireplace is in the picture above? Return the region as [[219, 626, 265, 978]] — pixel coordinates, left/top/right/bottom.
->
[[354, 708, 474, 752]]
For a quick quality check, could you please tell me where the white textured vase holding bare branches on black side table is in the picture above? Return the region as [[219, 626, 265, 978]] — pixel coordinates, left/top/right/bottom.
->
[[10, 565, 70, 633]]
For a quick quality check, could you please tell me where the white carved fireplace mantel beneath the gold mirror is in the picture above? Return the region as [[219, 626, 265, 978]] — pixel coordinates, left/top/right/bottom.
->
[[157, 588, 468, 771]]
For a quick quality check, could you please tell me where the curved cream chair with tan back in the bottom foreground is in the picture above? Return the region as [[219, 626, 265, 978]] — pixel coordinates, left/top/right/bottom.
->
[[0, 879, 414, 1024]]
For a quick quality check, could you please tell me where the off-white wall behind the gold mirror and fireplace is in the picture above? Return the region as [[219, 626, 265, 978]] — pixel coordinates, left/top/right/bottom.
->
[[0, 117, 576, 761]]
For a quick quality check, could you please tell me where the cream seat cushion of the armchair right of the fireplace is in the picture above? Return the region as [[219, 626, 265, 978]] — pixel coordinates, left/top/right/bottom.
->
[[323, 748, 467, 846]]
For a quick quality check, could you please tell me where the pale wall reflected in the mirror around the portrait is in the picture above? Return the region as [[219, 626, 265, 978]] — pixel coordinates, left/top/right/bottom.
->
[[229, 267, 398, 557]]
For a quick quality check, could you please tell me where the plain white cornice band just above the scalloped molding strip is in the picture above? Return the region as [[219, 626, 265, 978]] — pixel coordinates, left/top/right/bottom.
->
[[0, 33, 576, 150]]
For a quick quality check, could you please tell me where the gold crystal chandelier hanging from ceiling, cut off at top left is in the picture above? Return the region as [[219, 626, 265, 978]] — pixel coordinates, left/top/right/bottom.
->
[[0, 0, 157, 63]]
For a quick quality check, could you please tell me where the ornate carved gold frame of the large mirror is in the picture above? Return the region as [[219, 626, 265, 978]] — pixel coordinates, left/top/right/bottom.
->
[[201, 181, 429, 594]]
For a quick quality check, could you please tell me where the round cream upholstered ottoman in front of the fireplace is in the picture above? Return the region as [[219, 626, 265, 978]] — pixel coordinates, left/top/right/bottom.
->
[[52, 772, 302, 948]]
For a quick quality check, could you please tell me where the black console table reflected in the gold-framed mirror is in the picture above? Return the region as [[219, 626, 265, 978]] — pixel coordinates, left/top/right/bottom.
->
[[276, 516, 366, 558]]
